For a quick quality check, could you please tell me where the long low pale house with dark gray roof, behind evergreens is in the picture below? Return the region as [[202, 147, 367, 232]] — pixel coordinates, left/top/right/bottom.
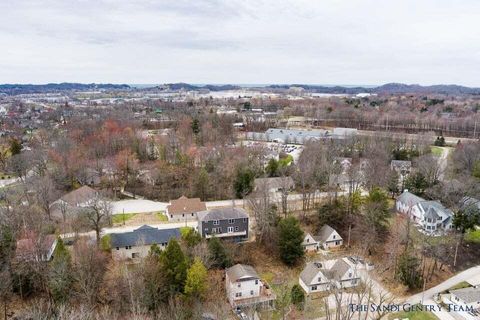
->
[[110, 225, 180, 260]]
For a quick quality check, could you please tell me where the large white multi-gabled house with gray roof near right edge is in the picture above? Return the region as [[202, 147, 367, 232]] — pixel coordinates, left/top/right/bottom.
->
[[396, 190, 453, 233]]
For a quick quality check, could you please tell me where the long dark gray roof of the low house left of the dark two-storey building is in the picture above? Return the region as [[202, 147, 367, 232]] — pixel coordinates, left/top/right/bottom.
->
[[110, 225, 180, 248]]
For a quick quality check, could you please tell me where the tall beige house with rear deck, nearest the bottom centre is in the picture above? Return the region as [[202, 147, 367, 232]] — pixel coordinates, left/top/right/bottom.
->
[[225, 264, 276, 308]]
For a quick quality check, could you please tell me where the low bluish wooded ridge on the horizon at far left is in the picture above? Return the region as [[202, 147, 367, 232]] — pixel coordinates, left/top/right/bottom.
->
[[0, 82, 130, 95]]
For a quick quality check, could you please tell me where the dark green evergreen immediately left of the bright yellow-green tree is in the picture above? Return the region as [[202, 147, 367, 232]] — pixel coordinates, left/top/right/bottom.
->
[[160, 239, 187, 293]]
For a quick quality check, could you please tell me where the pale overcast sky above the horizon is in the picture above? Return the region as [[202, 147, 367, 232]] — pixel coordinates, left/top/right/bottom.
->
[[0, 0, 480, 87]]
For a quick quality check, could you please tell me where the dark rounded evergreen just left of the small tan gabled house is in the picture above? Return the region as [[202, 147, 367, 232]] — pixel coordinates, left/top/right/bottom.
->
[[278, 217, 305, 266]]
